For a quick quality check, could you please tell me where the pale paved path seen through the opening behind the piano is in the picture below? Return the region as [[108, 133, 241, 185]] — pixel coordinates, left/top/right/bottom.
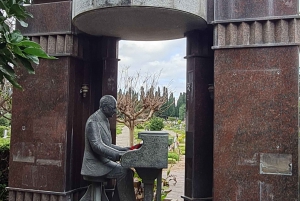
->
[[116, 127, 185, 201]]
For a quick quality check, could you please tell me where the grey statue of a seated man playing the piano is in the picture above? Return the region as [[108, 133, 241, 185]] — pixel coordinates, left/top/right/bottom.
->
[[81, 95, 135, 201]]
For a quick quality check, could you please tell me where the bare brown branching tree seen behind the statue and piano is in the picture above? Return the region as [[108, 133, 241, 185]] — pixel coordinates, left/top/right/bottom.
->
[[117, 68, 168, 146]]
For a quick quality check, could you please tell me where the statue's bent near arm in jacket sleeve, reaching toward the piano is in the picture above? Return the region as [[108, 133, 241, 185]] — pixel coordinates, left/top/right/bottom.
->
[[86, 122, 124, 161]]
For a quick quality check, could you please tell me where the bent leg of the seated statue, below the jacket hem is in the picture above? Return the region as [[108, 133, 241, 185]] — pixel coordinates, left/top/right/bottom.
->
[[106, 164, 135, 201]]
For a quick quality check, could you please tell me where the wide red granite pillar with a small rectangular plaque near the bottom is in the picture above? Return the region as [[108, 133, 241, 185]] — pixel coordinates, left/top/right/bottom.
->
[[213, 0, 299, 201]]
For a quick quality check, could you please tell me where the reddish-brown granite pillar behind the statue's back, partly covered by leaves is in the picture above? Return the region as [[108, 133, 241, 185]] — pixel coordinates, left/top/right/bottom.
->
[[8, 1, 117, 201]]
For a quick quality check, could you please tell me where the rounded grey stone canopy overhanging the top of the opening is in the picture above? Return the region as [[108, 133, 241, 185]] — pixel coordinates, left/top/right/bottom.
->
[[73, 0, 206, 41]]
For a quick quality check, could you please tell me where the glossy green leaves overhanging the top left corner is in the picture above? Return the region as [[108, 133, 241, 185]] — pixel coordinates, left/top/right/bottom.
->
[[0, 0, 56, 89]]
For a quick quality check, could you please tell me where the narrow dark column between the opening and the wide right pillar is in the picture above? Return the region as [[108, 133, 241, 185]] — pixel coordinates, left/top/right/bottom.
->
[[183, 27, 213, 200]]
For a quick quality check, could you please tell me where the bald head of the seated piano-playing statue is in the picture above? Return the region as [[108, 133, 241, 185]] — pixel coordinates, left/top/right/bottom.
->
[[99, 95, 117, 118]]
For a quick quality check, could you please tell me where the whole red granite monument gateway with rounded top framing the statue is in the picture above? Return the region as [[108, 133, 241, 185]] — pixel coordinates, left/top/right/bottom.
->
[[8, 0, 300, 201]]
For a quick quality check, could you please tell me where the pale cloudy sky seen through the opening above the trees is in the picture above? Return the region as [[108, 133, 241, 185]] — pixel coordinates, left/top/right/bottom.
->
[[119, 38, 186, 99]]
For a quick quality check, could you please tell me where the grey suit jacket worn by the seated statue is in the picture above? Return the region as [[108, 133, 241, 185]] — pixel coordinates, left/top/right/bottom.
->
[[81, 109, 127, 177]]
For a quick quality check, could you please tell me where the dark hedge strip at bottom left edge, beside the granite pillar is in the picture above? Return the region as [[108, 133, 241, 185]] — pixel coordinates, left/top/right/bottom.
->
[[0, 138, 10, 201]]
